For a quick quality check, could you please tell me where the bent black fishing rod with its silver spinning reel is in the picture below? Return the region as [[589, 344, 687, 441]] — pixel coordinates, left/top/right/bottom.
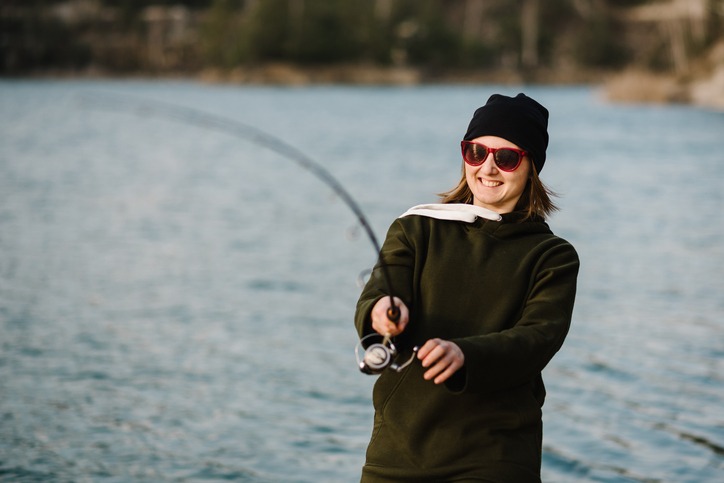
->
[[80, 93, 408, 374]]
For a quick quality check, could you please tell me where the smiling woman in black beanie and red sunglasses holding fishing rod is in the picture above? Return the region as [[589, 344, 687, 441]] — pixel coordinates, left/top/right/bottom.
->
[[355, 94, 579, 483]]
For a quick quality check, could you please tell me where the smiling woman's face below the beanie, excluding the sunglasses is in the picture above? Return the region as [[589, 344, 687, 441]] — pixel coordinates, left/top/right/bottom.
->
[[465, 136, 530, 214]]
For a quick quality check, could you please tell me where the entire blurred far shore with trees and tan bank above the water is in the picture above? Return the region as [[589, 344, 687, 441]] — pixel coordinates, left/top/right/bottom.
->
[[0, 0, 724, 111]]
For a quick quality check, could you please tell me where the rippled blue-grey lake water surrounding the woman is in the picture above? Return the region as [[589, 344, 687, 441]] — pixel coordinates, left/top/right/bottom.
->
[[0, 81, 724, 483]]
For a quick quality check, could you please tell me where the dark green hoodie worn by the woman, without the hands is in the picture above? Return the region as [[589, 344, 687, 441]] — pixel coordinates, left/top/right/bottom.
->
[[355, 209, 579, 483]]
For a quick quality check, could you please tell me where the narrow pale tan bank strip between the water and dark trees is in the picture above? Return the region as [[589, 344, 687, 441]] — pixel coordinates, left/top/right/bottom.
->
[[14, 61, 724, 112]]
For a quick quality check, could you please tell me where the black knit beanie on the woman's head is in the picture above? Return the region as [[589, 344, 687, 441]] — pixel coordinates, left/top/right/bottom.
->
[[464, 93, 548, 173]]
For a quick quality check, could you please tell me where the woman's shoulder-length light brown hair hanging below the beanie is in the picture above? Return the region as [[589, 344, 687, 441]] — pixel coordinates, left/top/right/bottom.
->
[[438, 161, 558, 220]]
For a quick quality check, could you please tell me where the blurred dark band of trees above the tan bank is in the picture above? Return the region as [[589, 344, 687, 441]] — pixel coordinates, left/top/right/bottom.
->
[[0, 0, 724, 79]]
